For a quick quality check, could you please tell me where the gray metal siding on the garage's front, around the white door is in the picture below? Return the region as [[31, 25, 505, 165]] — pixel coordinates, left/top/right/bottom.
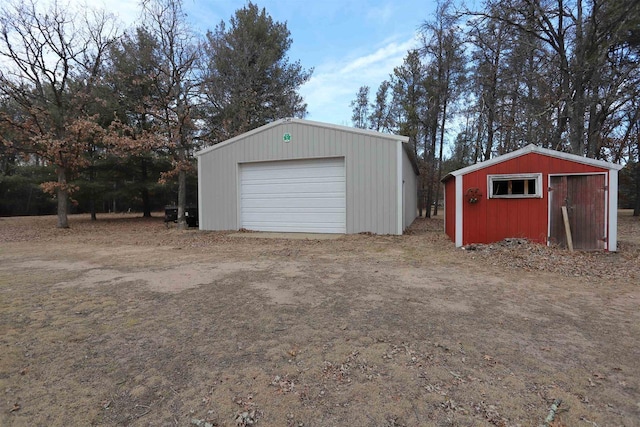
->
[[198, 122, 408, 234]]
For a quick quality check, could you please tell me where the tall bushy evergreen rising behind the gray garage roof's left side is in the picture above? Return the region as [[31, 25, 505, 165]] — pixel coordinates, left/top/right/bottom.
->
[[203, 2, 312, 144]]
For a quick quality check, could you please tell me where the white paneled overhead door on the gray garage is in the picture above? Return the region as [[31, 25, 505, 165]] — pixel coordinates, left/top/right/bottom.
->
[[240, 158, 346, 233]]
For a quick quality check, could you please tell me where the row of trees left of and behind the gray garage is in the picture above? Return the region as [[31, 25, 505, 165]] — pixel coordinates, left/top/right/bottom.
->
[[0, 0, 312, 228]]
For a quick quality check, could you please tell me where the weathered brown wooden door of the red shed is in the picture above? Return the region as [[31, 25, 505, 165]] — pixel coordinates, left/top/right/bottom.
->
[[549, 174, 606, 250]]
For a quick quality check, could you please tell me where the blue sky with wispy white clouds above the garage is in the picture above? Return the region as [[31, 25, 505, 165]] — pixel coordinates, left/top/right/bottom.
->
[[105, 0, 435, 125]]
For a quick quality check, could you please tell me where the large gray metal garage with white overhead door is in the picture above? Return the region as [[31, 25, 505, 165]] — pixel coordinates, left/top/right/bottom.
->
[[196, 119, 418, 234]]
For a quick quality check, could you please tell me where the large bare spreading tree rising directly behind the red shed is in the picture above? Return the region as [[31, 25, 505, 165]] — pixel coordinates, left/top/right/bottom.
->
[[469, 0, 640, 157]]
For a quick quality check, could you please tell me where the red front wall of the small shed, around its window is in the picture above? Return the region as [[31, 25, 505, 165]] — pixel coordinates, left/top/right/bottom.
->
[[462, 153, 608, 245]]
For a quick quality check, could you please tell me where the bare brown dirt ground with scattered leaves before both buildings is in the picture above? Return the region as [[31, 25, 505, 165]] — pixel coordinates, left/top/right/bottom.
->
[[0, 211, 640, 426]]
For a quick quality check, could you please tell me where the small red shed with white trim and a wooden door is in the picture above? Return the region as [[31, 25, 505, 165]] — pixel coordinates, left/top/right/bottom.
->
[[442, 144, 622, 251]]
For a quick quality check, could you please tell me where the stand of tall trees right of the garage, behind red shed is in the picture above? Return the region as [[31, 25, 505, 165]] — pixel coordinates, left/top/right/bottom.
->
[[351, 0, 640, 216]]
